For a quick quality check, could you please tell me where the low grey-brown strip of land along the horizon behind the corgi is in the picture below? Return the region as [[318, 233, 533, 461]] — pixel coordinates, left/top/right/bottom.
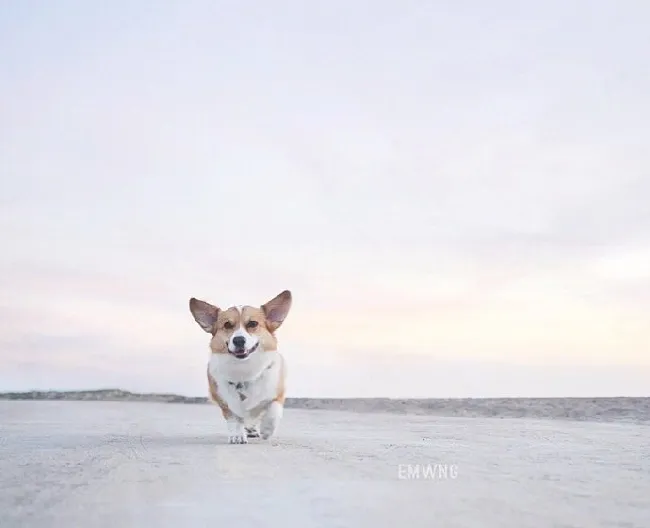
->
[[0, 389, 650, 424]]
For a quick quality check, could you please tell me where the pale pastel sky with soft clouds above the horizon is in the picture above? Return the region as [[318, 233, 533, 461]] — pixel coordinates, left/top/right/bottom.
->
[[0, 0, 650, 397]]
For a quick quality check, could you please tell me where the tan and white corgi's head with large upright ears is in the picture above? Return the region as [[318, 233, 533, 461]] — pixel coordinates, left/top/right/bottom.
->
[[190, 290, 291, 359]]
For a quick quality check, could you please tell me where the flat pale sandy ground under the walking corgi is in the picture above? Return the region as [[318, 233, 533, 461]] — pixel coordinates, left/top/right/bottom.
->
[[0, 401, 650, 528]]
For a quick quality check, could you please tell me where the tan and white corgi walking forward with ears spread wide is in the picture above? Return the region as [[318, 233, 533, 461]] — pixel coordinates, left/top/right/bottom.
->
[[190, 290, 292, 444]]
